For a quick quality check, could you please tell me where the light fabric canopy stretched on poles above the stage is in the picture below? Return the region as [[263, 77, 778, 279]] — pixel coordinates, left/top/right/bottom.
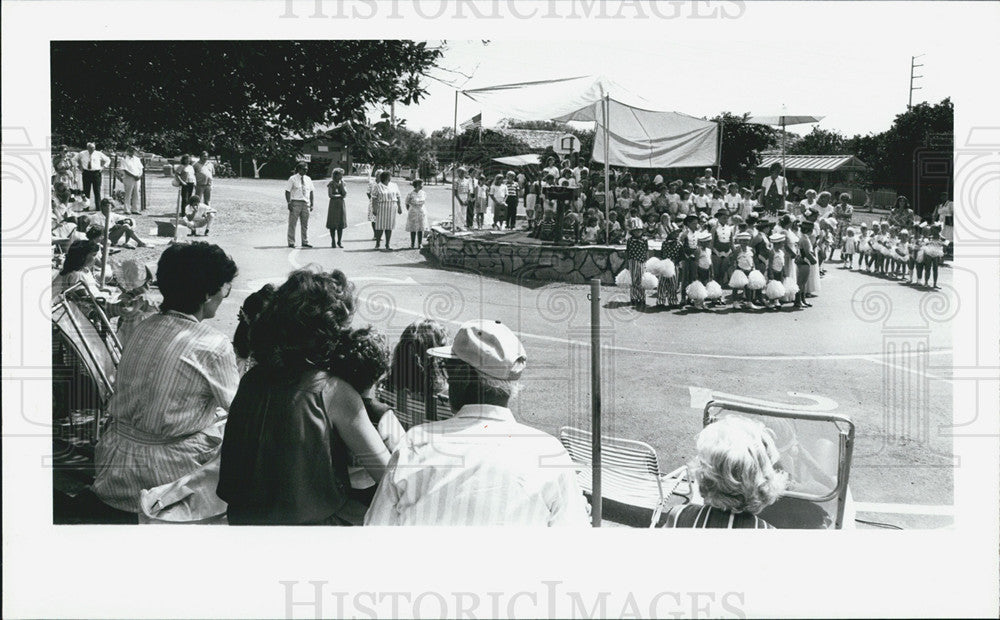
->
[[462, 76, 719, 168]]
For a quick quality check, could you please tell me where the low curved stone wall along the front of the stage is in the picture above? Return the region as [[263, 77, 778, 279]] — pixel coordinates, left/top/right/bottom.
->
[[424, 227, 625, 285]]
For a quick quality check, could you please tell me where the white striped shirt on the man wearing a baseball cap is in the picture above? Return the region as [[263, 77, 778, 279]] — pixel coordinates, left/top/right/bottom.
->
[[365, 405, 588, 527]]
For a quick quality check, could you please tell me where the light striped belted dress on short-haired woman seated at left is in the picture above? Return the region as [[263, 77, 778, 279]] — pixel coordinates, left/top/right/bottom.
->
[[94, 311, 239, 512]]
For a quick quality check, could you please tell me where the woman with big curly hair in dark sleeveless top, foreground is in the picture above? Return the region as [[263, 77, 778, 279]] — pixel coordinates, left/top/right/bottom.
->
[[218, 268, 389, 525]]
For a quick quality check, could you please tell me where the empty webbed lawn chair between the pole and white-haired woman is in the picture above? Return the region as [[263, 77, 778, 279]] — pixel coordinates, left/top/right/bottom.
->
[[559, 426, 684, 527]]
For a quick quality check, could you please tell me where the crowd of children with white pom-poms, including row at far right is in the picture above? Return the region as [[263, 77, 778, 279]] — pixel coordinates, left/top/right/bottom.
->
[[615, 208, 948, 310]]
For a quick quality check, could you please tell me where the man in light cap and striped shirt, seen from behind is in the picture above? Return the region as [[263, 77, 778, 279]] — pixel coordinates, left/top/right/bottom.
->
[[365, 320, 588, 527]]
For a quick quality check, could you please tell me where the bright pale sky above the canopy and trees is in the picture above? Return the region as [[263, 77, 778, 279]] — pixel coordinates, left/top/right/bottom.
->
[[396, 38, 964, 136]]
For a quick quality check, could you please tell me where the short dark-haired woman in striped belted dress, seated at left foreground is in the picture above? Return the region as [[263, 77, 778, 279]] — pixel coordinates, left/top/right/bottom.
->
[[94, 242, 239, 514]]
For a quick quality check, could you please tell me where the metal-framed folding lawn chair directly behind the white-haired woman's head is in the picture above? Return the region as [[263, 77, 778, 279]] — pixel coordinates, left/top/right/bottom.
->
[[703, 401, 854, 529]]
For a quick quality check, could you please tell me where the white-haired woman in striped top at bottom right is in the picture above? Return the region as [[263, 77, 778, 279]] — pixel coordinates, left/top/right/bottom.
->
[[666, 415, 788, 529]]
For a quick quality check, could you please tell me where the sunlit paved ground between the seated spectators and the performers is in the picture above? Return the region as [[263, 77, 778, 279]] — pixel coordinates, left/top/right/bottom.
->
[[162, 179, 954, 527]]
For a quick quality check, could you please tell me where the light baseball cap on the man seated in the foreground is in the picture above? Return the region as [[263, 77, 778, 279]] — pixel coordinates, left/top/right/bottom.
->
[[427, 319, 527, 381]]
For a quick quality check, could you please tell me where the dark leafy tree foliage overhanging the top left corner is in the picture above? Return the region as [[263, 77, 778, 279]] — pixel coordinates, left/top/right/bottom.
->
[[51, 40, 442, 172]]
